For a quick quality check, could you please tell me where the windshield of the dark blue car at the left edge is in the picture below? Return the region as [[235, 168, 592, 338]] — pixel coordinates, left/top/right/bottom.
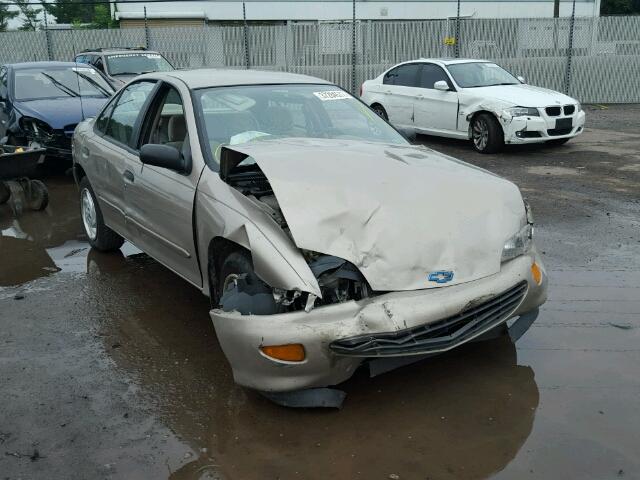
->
[[14, 66, 113, 100]]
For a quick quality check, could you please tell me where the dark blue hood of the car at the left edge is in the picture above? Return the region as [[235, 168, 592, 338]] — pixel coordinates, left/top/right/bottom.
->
[[14, 97, 109, 130]]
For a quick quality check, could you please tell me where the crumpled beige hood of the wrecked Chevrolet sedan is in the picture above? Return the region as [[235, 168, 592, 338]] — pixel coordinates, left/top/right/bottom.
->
[[228, 139, 525, 291]]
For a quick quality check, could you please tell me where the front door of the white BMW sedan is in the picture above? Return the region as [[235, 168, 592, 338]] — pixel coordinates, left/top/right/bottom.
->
[[415, 63, 458, 131]]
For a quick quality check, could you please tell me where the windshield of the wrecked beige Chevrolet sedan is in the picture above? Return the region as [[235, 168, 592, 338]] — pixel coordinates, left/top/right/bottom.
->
[[196, 84, 407, 161]]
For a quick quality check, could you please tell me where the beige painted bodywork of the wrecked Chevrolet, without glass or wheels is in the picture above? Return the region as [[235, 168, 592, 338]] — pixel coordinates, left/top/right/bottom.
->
[[73, 70, 547, 392]]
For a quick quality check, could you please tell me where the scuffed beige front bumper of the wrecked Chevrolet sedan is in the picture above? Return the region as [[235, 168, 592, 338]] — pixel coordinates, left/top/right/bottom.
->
[[210, 252, 547, 392]]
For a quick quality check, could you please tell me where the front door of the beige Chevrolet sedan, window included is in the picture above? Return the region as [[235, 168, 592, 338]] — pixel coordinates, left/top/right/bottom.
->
[[125, 82, 202, 287]]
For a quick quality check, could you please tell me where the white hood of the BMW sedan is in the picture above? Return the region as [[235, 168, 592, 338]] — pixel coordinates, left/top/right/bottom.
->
[[464, 84, 576, 107]]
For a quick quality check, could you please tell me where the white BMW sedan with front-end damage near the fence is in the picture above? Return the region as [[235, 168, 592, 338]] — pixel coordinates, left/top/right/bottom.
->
[[360, 59, 585, 153]]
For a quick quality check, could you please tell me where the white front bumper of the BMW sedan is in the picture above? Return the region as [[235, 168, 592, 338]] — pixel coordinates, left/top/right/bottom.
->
[[501, 111, 585, 144]]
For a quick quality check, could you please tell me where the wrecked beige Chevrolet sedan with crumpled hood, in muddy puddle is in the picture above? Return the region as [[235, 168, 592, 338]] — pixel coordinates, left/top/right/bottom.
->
[[73, 70, 547, 406]]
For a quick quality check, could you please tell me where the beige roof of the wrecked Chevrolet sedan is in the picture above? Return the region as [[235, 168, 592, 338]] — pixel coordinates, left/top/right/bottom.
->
[[148, 68, 332, 89]]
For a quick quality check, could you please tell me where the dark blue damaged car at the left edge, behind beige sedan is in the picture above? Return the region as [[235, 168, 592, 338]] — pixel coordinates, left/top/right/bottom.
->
[[0, 62, 114, 159]]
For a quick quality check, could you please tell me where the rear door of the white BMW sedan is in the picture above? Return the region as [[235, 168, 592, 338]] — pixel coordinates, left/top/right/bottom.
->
[[381, 63, 421, 127]]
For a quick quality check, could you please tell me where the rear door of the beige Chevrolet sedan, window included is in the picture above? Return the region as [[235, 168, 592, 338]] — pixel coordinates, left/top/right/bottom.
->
[[87, 81, 156, 238]]
